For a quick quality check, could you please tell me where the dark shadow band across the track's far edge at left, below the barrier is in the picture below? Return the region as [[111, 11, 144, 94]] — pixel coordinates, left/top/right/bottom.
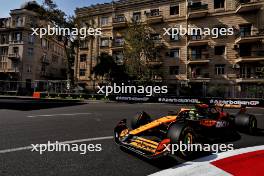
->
[[0, 99, 86, 111]]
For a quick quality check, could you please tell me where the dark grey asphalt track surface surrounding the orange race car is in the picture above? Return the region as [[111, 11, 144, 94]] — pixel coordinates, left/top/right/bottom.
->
[[0, 100, 264, 176]]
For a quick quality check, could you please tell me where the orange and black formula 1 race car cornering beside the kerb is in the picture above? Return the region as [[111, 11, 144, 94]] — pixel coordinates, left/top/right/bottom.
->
[[114, 104, 257, 159]]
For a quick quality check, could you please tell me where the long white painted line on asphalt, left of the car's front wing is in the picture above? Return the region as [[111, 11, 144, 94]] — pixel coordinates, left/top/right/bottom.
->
[[0, 136, 114, 154]]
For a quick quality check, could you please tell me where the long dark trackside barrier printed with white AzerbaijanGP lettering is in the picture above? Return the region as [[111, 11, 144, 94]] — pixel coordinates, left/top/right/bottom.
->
[[108, 95, 264, 107]]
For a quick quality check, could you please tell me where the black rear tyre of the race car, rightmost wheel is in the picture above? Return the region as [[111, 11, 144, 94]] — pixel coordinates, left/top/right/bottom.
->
[[235, 114, 257, 134]]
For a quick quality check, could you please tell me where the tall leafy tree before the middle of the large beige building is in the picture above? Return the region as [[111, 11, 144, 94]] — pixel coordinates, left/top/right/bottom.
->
[[124, 21, 162, 82]]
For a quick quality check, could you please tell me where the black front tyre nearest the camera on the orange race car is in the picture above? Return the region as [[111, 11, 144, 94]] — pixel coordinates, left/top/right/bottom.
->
[[167, 123, 196, 160]]
